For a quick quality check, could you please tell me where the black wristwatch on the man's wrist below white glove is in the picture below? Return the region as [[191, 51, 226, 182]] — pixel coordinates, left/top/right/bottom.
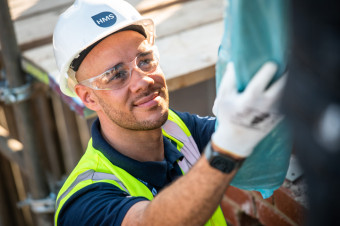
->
[[204, 142, 243, 173]]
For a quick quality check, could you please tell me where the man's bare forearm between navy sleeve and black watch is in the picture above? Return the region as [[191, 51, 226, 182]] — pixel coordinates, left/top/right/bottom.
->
[[122, 157, 237, 225]]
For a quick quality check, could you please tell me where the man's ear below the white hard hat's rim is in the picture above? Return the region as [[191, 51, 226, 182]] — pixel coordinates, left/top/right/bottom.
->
[[74, 84, 100, 111]]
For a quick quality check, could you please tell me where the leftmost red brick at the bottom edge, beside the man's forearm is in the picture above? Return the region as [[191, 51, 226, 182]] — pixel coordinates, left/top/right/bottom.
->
[[221, 196, 241, 226]]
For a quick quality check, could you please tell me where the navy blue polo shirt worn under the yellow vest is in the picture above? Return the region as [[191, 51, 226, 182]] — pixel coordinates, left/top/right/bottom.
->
[[58, 111, 215, 225]]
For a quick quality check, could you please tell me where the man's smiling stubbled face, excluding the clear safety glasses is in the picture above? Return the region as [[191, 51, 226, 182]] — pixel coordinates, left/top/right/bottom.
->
[[76, 31, 169, 130]]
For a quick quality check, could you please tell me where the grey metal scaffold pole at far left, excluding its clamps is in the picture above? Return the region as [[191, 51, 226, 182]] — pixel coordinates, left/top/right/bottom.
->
[[0, 0, 52, 225]]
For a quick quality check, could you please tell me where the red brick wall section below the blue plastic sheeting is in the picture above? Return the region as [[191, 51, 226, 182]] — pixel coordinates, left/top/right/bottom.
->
[[221, 180, 306, 226]]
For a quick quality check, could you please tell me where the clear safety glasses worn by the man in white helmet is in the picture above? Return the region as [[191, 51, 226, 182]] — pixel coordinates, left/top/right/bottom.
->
[[79, 46, 159, 90]]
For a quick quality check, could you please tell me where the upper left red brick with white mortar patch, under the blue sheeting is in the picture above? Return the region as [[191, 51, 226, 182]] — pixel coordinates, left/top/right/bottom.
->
[[225, 186, 255, 217]]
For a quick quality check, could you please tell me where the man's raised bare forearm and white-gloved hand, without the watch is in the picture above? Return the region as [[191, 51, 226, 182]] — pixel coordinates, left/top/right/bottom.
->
[[122, 63, 285, 225]]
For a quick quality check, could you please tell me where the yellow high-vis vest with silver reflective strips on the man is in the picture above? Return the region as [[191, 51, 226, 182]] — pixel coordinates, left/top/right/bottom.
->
[[54, 110, 227, 226]]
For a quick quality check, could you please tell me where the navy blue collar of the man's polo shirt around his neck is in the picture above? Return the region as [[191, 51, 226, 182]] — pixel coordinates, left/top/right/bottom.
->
[[91, 119, 184, 187]]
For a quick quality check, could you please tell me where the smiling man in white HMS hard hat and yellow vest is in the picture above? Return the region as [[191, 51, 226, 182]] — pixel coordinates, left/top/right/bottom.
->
[[53, 0, 283, 225]]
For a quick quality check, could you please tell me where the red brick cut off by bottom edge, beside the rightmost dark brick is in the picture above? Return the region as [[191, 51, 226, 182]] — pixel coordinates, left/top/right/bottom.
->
[[256, 200, 296, 226]]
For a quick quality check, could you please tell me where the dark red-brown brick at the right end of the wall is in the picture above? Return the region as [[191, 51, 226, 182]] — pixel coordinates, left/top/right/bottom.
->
[[274, 187, 306, 225]]
